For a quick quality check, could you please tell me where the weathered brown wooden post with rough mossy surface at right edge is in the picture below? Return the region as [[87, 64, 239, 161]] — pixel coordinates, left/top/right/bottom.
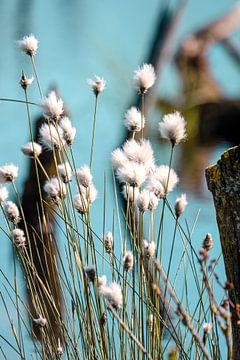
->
[[206, 146, 240, 360]]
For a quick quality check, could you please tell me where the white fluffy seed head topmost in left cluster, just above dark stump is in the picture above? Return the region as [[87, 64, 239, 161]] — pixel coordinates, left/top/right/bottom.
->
[[43, 90, 64, 120]]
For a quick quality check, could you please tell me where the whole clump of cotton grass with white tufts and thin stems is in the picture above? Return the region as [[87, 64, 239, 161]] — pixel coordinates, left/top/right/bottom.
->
[[0, 35, 234, 359]]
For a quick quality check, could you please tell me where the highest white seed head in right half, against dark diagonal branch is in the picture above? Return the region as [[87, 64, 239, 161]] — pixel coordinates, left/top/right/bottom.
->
[[133, 64, 156, 94]]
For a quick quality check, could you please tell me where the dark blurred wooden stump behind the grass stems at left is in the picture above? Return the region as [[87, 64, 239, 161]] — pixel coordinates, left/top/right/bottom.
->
[[20, 117, 62, 339]]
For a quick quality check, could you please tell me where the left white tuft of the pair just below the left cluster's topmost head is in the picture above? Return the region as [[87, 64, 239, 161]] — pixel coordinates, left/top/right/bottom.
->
[[39, 124, 65, 150]]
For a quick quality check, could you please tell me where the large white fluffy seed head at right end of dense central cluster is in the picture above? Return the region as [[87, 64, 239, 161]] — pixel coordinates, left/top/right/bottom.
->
[[153, 165, 178, 195]]
